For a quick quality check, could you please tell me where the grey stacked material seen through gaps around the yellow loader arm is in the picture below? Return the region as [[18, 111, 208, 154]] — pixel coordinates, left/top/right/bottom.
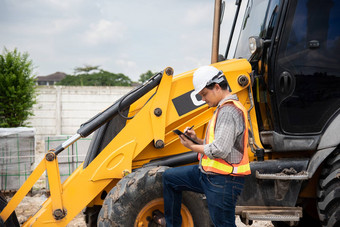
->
[[45, 136, 91, 188]]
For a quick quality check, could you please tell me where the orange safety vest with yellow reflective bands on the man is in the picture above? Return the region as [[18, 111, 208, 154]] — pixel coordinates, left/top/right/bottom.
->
[[198, 100, 250, 176]]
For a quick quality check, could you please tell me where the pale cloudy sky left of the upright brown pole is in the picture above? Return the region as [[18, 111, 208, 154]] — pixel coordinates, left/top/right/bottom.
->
[[0, 0, 218, 81]]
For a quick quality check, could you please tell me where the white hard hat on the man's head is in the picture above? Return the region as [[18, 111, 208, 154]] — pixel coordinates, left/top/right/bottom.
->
[[192, 65, 223, 93]]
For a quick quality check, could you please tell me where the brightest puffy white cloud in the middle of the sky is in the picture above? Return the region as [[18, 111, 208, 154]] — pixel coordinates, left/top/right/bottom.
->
[[84, 19, 127, 45]]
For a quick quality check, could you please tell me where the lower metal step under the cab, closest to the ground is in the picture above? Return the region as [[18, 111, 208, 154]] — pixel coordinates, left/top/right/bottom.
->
[[236, 206, 302, 225]]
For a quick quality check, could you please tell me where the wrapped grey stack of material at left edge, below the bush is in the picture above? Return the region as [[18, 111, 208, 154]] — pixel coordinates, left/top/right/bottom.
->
[[0, 128, 35, 191]]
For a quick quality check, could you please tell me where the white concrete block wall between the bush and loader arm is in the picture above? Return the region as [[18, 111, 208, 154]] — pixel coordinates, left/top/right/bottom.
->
[[28, 86, 133, 140]]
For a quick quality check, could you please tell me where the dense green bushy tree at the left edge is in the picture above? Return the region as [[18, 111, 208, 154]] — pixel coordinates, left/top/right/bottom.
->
[[0, 48, 36, 128]]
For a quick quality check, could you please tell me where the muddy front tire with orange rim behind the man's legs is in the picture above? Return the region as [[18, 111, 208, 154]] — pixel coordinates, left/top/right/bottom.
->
[[98, 167, 210, 227]]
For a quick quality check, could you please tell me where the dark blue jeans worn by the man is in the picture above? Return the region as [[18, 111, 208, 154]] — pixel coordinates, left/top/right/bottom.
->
[[163, 165, 244, 227]]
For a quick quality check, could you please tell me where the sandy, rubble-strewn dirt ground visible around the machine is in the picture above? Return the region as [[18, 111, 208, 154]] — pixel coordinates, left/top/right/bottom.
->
[[7, 141, 273, 227]]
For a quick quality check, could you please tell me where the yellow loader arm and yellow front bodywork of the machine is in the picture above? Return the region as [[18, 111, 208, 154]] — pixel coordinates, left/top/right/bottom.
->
[[1, 60, 260, 226]]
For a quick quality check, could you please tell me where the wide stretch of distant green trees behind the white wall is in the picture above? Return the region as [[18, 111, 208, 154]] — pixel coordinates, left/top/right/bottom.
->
[[57, 70, 132, 86]]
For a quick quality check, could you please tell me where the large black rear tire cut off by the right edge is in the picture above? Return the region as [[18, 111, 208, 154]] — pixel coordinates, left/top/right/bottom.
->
[[317, 149, 340, 227]]
